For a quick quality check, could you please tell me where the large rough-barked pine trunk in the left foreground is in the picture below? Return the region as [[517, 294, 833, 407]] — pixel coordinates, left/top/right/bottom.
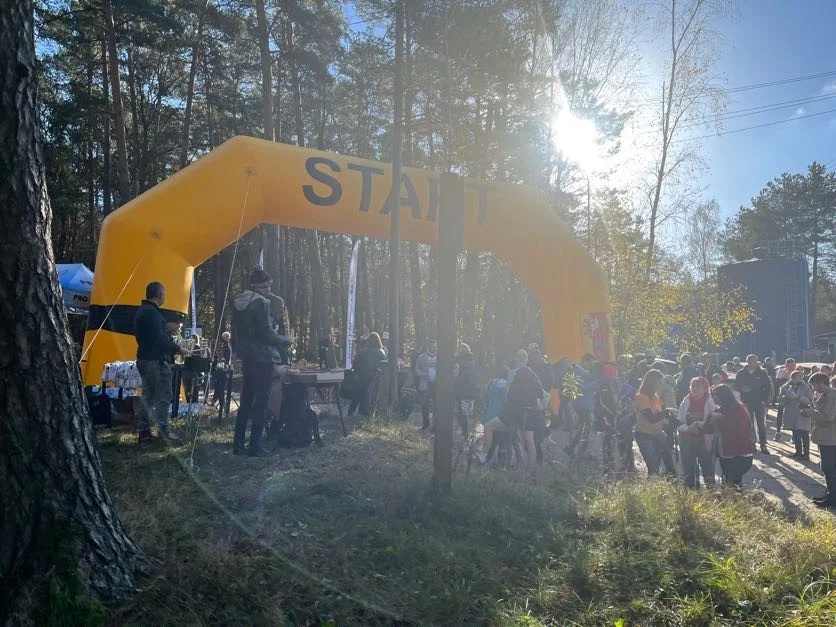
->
[[0, 0, 139, 617]]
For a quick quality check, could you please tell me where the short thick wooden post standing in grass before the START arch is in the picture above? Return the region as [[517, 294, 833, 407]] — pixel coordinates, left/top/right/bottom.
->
[[433, 174, 464, 492]]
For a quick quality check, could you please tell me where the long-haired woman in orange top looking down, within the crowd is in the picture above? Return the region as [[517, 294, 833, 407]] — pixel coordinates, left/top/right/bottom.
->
[[633, 370, 676, 477]]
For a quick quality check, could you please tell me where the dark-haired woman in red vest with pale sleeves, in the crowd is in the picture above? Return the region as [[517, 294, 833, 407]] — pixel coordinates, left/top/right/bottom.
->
[[704, 384, 755, 488]]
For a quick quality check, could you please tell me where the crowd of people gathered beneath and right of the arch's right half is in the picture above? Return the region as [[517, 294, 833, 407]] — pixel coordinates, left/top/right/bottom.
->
[[404, 343, 836, 507]]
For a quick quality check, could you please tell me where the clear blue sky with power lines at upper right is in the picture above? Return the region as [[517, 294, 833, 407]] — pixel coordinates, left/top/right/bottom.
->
[[703, 0, 836, 217]]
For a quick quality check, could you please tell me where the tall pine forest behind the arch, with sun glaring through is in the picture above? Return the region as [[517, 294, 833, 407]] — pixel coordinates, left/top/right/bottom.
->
[[36, 0, 836, 359]]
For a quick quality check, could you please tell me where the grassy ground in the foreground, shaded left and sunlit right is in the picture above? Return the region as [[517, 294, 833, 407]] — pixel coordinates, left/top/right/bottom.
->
[[100, 414, 836, 626]]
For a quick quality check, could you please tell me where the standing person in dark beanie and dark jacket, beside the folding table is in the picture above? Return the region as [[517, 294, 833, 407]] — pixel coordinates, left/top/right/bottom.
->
[[232, 268, 290, 457]]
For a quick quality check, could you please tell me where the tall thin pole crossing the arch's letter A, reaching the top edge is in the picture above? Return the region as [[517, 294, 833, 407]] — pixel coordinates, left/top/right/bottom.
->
[[388, 0, 404, 408]]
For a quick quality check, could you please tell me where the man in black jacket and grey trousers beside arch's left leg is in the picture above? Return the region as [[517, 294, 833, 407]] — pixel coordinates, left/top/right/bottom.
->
[[134, 281, 186, 444]]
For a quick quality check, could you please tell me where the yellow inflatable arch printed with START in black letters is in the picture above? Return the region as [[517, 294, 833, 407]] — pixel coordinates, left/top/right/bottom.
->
[[81, 137, 610, 385]]
